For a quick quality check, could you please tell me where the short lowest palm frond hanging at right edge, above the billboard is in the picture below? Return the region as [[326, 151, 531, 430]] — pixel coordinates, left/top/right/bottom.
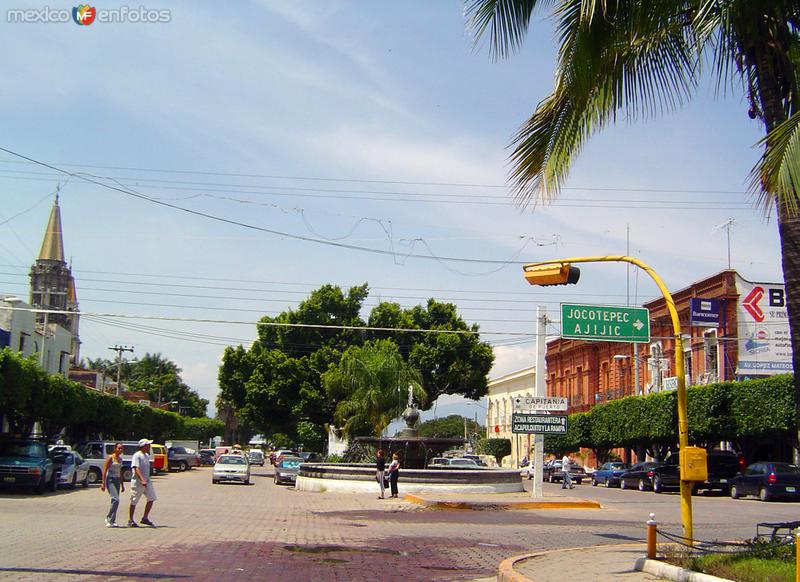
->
[[750, 112, 800, 216]]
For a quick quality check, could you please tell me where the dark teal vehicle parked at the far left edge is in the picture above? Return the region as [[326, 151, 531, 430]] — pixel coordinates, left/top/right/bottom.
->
[[0, 439, 57, 494]]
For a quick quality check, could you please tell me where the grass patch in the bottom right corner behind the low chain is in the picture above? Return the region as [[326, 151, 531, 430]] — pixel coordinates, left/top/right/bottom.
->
[[665, 540, 795, 582]]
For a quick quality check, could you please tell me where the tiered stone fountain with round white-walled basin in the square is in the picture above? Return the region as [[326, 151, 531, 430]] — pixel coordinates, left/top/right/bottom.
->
[[295, 386, 524, 493]]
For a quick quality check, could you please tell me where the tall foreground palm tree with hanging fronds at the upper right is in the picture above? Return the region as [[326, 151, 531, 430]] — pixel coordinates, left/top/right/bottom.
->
[[467, 0, 800, 456]]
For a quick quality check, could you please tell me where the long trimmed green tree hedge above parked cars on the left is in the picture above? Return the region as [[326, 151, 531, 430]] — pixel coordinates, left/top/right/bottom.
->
[[0, 348, 223, 442]]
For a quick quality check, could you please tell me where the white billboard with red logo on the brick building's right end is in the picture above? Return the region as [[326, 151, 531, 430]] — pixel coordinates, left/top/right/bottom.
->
[[736, 275, 792, 376]]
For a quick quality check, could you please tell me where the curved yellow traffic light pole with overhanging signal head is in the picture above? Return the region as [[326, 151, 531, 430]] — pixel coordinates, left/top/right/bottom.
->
[[523, 255, 694, 544]]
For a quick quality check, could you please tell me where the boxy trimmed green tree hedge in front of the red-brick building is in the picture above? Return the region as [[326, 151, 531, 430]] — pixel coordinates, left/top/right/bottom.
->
[[545, 375, 796, 456]]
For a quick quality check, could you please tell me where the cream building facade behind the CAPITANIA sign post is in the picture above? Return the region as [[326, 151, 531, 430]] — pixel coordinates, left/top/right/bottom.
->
[[486, 366, 536, 467]]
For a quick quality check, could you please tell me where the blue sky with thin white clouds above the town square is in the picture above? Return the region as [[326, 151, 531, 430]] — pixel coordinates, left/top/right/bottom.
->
[[0, 0, 783, 422]]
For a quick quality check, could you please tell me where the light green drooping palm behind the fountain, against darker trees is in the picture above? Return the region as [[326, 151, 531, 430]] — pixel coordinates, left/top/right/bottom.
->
[[322, 340, 427, 437]]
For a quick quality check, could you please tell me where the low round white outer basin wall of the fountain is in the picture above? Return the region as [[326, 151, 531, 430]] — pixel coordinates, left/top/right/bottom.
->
[[295, 463, 524, 494]]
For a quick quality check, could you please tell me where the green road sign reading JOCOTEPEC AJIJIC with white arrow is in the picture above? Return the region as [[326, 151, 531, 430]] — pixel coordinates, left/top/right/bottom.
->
[[561, 303, 650, 343]]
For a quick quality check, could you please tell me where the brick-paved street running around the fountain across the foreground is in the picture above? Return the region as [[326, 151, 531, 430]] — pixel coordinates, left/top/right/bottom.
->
[[0, 467, 800, 581]]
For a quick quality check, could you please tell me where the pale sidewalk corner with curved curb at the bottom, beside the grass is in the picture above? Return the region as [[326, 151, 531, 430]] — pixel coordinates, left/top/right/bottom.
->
[[497, 544, 665, 582]]
